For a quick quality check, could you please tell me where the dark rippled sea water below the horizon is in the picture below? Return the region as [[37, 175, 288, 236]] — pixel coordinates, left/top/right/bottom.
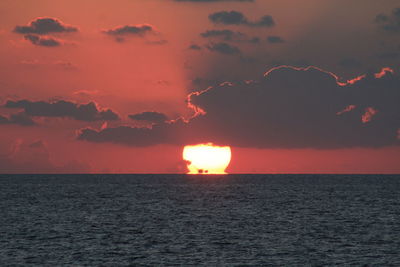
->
[[0, 175, 400, 266]]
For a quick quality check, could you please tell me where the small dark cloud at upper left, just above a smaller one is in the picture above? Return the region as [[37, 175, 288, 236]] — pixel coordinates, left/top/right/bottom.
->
[[14, 18, 78, 34]]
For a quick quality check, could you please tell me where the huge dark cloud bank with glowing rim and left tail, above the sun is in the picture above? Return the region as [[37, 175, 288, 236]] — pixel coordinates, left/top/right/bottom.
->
[[78, 66, 400, 149]]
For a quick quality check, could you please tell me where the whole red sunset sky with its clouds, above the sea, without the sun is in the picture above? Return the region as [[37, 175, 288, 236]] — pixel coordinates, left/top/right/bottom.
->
[[0, 0, 400, 173]]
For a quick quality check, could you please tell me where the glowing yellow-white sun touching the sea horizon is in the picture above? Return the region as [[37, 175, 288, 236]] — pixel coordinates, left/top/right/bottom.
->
[[182, 143, 231, 174]]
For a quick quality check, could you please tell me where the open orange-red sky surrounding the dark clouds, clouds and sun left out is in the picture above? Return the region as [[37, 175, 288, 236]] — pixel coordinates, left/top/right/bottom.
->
[[0, 0, 400, 173]]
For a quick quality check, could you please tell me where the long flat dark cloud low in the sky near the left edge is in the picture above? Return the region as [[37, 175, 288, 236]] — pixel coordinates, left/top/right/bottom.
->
[[5, 100, 119, 121]]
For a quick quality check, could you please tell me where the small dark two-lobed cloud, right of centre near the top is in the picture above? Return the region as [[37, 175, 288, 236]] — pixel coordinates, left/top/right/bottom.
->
[[208, 10, 275, 27]]
